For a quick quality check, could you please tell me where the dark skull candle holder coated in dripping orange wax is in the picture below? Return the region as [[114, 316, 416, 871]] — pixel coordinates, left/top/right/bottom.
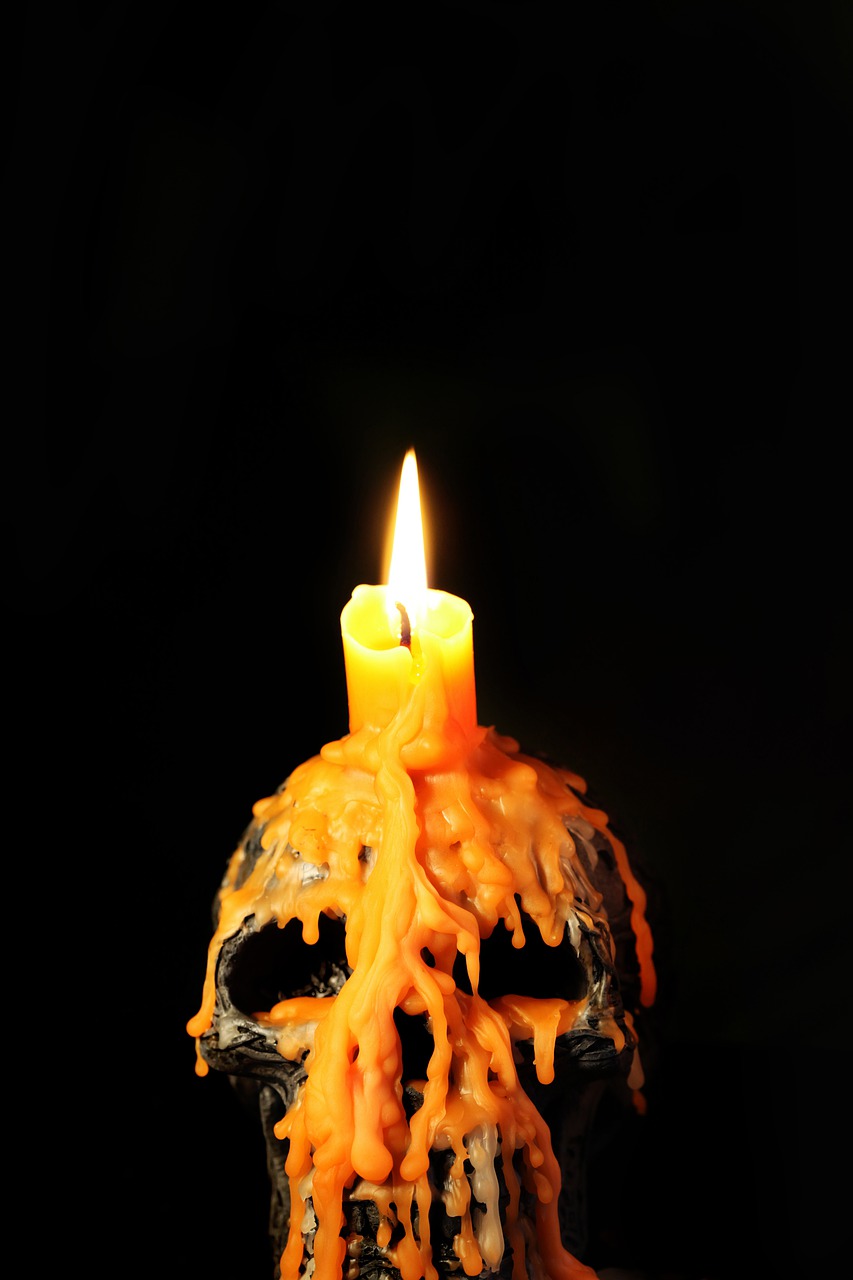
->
[[188, 730, 653, 1280]]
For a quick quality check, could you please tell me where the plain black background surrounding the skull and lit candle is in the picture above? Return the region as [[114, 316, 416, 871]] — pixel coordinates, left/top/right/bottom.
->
[[4, 0, 853, 1280]]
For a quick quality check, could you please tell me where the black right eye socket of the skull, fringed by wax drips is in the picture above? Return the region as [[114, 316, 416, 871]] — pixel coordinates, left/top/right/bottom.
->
[[453, 911, 588, 1000]]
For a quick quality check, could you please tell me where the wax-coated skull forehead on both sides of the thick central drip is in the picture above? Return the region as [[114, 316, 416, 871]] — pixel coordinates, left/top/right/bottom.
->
[[211, 753, 625, 967]]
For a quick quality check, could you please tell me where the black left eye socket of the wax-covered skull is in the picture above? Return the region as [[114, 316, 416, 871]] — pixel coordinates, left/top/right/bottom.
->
[[228, 915, 351, 1016]]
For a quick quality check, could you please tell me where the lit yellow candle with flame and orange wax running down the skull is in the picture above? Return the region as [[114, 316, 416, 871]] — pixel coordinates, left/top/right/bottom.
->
[[187, 454, 654, 1280]]
